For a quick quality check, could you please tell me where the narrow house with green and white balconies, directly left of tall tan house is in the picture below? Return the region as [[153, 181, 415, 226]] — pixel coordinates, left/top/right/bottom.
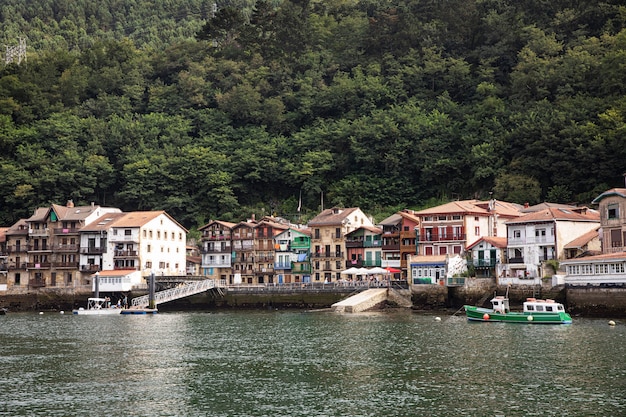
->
[[274, 227, 311, 284]]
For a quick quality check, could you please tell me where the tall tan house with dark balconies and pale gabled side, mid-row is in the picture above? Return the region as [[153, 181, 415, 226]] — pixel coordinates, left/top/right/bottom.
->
[[308, 207, 374, 282]]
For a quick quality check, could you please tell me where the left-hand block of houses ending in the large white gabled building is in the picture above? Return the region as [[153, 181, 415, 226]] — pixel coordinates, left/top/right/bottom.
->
[[0, 200, 187, 293]]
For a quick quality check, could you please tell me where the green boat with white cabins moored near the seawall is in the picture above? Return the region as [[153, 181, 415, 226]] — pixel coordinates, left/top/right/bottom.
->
[[464, 296, 572, 324]]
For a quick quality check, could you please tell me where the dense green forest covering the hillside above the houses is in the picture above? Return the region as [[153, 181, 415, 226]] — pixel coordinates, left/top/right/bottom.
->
[[0, 0, 626, 229]]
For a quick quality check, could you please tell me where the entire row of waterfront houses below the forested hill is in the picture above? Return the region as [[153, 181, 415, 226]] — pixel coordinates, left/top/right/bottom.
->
[[0, 182, 626, 292]]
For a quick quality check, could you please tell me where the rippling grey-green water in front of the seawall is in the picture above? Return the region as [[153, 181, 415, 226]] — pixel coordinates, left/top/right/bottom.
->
[[0, 311, 626, 417]]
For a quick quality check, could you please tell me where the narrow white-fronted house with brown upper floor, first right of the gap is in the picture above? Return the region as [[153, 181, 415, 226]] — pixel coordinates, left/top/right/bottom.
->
[[199, 220, 235, 284]]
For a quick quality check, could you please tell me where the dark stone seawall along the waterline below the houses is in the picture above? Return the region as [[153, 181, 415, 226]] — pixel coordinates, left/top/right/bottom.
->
[[0, 279, 626, 318]]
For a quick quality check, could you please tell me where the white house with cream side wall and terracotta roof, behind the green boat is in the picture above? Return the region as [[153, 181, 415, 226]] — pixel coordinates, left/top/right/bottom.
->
[[499, 207, 600, 285]]
